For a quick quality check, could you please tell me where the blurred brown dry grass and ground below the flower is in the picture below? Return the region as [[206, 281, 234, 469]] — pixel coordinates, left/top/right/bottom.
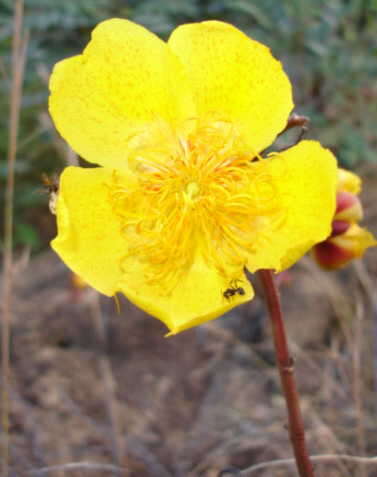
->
[[0, 166, 377, 477]]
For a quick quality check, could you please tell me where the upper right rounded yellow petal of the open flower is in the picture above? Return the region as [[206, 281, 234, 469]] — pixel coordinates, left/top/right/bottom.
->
[[168, 21, 293, 152]]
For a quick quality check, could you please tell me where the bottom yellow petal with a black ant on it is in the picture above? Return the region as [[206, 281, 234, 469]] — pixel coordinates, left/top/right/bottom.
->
[[120, 256, 254, 335]]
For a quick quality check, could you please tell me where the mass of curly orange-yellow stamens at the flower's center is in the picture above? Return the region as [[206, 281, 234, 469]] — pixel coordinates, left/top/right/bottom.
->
[[110, 121, 276, 293]]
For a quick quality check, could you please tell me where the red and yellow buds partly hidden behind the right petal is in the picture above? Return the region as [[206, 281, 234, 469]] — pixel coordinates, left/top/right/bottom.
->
[[313, 169, 377, 270]]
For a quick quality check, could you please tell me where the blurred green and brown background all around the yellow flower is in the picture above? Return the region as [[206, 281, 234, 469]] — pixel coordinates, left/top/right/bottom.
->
[[0, 0, 377, 477]]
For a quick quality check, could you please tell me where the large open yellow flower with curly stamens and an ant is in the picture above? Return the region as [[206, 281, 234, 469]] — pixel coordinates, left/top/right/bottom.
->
[[50, 19, 336, 334]]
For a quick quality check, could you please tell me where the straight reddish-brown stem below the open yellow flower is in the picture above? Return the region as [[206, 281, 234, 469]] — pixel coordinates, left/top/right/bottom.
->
[[258, 270, 314, 477]]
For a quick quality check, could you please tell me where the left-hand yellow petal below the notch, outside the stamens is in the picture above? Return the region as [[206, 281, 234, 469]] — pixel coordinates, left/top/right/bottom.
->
[[51, 167, 126, 296]]
